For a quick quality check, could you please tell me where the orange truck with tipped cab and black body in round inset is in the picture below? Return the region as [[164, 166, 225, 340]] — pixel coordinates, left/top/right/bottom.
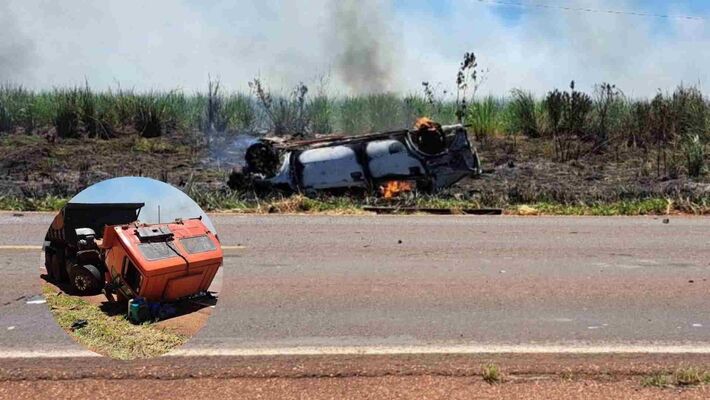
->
[[45, 203, 223, 302]]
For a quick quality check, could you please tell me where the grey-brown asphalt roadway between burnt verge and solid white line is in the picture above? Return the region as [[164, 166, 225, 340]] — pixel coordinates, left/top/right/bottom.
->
[[0, 213, 710, 355]]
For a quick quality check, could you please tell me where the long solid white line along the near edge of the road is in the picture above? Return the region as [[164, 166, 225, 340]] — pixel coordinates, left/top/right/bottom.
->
[[0, 344, 710, 359]]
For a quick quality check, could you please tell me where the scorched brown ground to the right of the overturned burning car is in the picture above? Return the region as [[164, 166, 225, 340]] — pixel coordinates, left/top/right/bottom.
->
[[462, 137, 710, 212]]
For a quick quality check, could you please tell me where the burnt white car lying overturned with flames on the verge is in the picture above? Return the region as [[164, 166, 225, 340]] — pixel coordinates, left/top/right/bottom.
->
[[243, 118, 481, 195]]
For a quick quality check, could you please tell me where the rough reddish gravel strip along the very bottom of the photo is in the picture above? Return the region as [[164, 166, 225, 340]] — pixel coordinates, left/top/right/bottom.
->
[[0, 376, 710, 400]]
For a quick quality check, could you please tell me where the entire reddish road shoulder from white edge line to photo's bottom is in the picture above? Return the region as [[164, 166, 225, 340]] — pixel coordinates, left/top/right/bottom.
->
[[0, 354, 710, 399]]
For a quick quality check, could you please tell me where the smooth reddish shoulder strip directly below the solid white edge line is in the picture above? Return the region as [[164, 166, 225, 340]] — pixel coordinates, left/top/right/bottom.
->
[[0, 353, 710, 381]]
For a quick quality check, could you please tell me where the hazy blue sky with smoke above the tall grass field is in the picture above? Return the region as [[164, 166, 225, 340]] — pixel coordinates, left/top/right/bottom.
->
[[0, 0, 710, 97]]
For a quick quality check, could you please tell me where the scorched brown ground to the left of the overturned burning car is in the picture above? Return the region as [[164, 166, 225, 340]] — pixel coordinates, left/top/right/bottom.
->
[[0, 134, 225, 198]]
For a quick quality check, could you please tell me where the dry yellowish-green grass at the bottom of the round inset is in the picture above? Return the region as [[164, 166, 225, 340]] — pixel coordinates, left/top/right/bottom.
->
[[42, 284, 188, 360]]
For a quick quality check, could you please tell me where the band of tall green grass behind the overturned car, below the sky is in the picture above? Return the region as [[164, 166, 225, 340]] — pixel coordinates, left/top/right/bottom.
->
[[0, 80, 710, 176]]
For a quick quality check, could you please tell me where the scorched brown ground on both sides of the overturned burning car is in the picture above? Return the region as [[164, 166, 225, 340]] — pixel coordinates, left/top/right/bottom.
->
[[0, 133, 710, 214]]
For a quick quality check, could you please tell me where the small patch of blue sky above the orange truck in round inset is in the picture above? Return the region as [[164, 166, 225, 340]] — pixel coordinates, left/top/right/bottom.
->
[[69, 176, 217, 234]]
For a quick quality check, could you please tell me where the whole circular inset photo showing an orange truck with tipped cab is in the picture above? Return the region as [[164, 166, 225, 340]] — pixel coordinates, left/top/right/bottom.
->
[[42, 177, 223, 359]]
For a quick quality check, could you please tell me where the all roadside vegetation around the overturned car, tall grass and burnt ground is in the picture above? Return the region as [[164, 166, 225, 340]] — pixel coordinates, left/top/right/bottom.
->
[[0, 53, 710, 215]]
